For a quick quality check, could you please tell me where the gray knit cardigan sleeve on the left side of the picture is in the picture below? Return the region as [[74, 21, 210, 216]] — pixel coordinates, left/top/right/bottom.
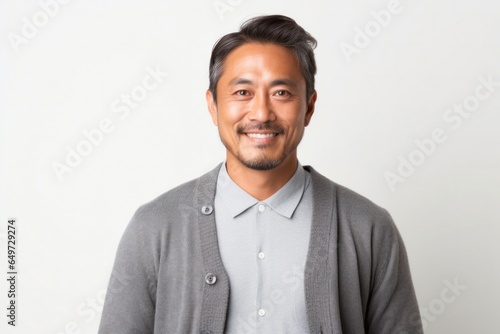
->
[[98, 208, 156, 334]]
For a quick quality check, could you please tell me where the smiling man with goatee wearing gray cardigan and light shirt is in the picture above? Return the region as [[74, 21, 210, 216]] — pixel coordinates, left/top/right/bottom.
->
[[99, 16, 422, 334]]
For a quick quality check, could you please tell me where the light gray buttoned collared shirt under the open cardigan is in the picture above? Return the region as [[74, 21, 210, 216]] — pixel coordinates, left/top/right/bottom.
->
[[214, 164, 313, 334]]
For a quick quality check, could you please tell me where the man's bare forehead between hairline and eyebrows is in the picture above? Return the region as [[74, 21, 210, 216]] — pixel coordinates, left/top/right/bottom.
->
[[220, 42, 305, 82]]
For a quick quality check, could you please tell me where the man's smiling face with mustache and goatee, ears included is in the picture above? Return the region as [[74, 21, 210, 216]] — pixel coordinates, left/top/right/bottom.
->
[[207, 43, 316, 170]]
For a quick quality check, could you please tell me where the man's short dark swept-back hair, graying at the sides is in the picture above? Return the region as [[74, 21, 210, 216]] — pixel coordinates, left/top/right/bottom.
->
[[208, 15, 317, 102]]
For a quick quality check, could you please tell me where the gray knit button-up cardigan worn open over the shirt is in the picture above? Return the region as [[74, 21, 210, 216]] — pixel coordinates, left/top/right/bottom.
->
[[99, 165, 423, 334]]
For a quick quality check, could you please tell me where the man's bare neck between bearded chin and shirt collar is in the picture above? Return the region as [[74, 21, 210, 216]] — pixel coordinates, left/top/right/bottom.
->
[[226, 156, 298, 201]]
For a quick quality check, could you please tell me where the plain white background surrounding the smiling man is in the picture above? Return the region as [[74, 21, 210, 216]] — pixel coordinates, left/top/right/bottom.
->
[[0, 0, 500, 334]]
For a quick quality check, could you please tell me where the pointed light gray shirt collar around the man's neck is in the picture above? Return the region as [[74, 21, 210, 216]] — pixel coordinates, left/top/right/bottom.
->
[[217, 163, 310, 219]]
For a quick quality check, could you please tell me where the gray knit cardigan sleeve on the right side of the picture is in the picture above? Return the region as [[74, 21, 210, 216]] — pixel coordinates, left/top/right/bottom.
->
[[365, 210, 423, 334]]
